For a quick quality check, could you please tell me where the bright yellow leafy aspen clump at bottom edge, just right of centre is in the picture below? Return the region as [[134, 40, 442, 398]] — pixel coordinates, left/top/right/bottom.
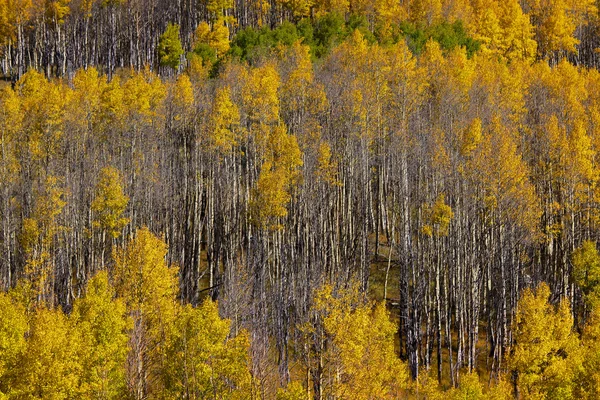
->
[[300, 285, 408, 400]]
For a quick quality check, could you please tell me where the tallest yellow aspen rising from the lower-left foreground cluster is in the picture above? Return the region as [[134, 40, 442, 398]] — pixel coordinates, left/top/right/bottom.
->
[[114, 228, 179, 396]]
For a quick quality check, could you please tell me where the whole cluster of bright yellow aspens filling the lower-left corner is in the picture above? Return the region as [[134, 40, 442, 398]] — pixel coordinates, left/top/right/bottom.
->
[[0, 229, 251, 399]]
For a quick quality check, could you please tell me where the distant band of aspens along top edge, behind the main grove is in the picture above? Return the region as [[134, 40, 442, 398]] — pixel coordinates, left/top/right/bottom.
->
[[0, 0, 600, 79]]
